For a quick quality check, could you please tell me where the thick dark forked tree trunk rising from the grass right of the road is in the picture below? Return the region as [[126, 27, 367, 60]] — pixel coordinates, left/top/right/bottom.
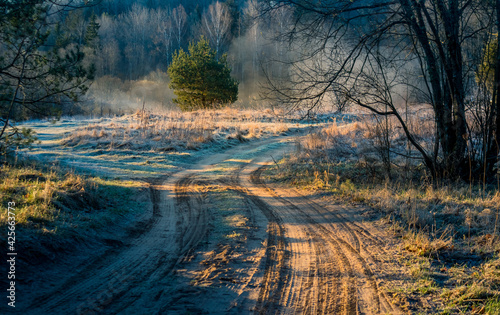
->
[[400, 0, 467, 177]]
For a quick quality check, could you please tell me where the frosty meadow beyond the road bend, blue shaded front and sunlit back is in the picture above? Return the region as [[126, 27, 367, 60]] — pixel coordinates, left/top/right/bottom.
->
[[23, 108, 300, 179]]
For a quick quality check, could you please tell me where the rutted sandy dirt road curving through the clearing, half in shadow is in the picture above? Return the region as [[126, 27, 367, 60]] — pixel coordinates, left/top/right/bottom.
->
[[24, 137, 401, 314]]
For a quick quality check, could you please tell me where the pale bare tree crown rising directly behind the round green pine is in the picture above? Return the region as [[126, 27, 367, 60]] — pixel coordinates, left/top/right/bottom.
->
[[202, 1, 232, 56]]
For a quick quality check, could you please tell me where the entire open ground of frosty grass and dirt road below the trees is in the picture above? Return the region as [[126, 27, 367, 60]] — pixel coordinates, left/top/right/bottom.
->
[[0, 109, 500, 314]]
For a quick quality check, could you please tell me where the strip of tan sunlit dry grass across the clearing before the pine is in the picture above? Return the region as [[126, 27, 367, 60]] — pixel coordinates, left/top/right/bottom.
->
[[62, 109, 290, 152]]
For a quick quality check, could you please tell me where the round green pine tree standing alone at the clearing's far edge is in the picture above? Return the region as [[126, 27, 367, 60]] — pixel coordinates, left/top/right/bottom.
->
[[168, 37, 238, 111]]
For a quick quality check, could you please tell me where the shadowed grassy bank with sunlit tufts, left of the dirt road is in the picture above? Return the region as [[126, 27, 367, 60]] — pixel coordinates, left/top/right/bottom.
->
[[0, 164, 144, 263]]
